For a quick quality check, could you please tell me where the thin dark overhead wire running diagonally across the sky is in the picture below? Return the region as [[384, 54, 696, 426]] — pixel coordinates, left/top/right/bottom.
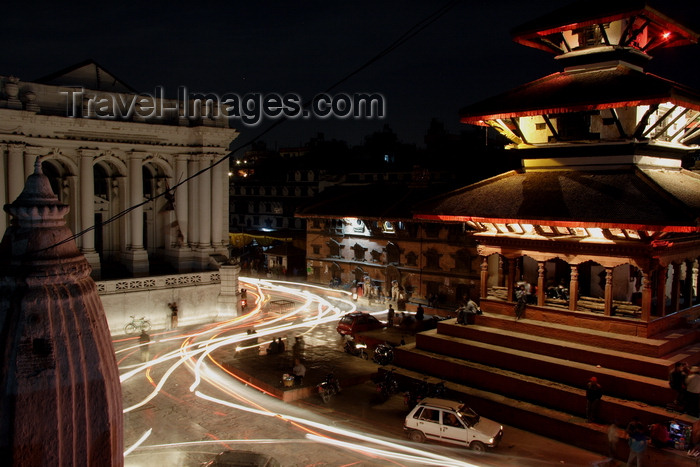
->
[[38, 0, 461, 253]]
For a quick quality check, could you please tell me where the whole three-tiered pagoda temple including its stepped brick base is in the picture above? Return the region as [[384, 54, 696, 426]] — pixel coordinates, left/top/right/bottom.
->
[[394, 0, 700, 458]]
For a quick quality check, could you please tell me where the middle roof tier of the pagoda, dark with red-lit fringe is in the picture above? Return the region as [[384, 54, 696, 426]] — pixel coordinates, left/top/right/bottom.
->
[[460, 65, 700, 124]]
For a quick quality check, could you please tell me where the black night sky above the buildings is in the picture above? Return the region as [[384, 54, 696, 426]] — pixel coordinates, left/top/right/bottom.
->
[[0, 0, 700, 146]]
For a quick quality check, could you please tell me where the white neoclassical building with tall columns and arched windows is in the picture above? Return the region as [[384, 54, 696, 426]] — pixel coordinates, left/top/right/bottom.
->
[[0, 61, 238, 278]]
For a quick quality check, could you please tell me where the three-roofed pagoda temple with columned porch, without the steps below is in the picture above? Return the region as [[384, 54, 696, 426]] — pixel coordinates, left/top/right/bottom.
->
[[416, 1, 700, 337]]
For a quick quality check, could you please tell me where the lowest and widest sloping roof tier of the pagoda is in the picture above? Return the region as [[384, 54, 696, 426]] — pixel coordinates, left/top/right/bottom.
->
[[414, 168, 700, 232]]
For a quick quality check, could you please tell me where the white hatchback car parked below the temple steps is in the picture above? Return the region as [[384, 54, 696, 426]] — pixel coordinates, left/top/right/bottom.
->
[[403, 397, 503, 452]]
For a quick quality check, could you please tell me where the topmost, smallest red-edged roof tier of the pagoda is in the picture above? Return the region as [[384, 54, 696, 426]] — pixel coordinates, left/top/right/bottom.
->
[[511, 0, 700, 52]]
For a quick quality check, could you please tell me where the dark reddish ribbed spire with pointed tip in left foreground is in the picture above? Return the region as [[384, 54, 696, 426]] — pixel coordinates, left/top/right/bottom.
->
[[0, 159, 124, 467]]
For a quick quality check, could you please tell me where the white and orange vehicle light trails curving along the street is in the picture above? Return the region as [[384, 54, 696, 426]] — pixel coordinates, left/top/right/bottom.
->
[[120, 278, 472, 467]]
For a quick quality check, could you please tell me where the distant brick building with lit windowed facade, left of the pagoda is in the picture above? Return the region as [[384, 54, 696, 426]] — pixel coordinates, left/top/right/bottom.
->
[[297, 171, 480, 305]]
